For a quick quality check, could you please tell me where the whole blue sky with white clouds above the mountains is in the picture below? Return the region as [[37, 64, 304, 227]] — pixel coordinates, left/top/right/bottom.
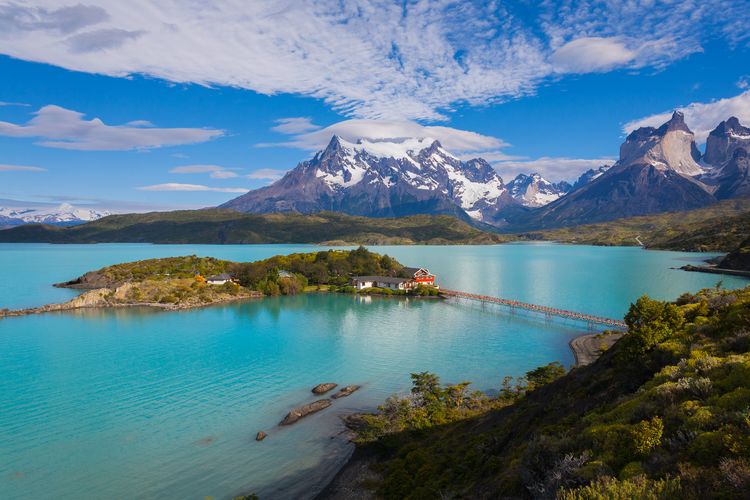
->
[[0, 0, 750, 211]]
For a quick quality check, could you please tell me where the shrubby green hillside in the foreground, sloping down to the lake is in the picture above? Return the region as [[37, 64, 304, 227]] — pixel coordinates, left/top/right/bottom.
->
[[352, 287, 750, 500]]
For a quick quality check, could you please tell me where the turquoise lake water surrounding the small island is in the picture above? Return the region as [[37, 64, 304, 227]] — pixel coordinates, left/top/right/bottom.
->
[[0, 243, 750, 499]]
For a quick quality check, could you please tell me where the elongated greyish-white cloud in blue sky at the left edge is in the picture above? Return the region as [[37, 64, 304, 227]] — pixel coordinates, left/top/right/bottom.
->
[[0, 105, 224, 151]]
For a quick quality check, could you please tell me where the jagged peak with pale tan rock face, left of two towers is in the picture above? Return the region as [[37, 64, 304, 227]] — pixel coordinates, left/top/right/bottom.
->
[[617, 111, 703, 176]]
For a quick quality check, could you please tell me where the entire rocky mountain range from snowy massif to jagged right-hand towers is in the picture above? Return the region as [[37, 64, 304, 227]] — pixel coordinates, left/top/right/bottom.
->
[[222, 112, 750, 230]]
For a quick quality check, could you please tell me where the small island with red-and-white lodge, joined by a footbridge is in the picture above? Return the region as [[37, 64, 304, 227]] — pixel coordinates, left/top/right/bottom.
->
[[0, 247, 438, 317]]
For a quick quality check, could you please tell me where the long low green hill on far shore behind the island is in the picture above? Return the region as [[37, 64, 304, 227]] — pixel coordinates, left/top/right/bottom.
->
[[0, 209, 512, 244]]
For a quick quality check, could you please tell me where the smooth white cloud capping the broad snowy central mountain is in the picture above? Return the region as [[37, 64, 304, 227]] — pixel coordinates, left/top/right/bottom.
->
[[264, 120, 509, 154]]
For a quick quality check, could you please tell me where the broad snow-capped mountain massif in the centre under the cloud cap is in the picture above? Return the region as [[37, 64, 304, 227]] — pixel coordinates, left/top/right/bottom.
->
[[222, 136, 516, 224]]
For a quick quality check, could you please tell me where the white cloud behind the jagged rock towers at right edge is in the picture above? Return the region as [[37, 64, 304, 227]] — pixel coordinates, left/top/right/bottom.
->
[[622, 90, 750, 143]]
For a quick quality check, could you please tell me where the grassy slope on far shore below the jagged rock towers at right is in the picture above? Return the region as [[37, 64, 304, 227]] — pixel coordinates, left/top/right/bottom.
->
[[524, 199, 750, 252]]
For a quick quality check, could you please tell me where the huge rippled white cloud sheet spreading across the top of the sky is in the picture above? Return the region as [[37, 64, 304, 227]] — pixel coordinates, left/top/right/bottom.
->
[[0, 0, 747, 120]]
